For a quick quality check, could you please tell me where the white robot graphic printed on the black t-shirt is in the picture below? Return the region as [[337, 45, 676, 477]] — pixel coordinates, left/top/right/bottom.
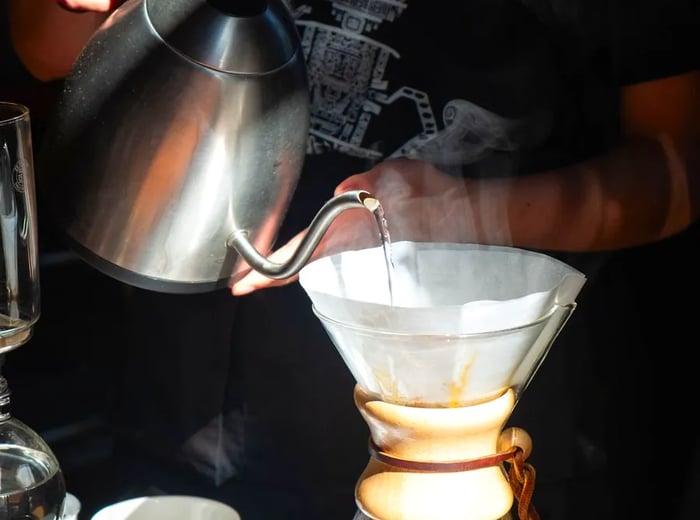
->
[[295, 0, 518, 164]]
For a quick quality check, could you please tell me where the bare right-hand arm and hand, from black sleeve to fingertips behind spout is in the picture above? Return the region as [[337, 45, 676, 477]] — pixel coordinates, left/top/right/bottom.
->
[[232, 72, 700, 295]]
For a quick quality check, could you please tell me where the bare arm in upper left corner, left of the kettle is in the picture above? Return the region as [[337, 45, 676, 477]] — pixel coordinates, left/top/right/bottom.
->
[[9, 0, 107, 81]]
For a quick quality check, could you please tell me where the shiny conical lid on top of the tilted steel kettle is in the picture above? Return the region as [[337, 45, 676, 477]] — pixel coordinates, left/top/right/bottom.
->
[[145, 0, 299, 74]]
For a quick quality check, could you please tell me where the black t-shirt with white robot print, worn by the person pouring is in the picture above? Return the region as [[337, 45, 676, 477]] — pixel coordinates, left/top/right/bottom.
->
[[286, 0, 700, 186]]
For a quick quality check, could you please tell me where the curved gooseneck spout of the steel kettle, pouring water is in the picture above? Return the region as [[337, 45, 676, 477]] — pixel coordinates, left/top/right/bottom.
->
[[227, 190, 379, 280]]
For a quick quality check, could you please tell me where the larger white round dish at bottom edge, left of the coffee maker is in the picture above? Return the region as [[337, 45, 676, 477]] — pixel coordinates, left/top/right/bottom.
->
[[92, 495, 241, 520]]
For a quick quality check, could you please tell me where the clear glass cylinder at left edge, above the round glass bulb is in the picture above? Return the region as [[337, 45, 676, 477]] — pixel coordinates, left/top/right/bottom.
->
[[0, 102, 41, 354]]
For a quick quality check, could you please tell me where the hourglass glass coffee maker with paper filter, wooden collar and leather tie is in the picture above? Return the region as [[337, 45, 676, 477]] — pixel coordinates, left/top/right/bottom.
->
[[299, 242, 585, 520]]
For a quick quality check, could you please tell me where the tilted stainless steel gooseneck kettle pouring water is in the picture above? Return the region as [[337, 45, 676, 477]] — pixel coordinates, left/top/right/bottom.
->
[[37, 0, 368, 292]]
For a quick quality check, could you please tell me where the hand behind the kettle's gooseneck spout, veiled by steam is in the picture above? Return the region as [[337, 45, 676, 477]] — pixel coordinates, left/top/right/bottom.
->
[[231, 159, 475, 296]]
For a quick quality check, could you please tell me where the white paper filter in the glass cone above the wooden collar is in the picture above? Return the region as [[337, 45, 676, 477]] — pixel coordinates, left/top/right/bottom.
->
[[299, 242, 585, 406]]
